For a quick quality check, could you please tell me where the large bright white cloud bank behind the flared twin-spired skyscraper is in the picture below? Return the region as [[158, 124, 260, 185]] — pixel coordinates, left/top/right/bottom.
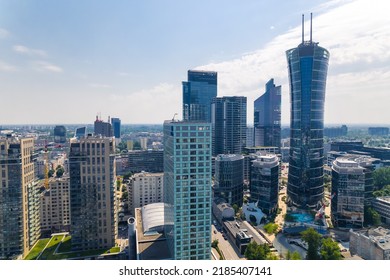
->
[[197, 0, 390, 123]]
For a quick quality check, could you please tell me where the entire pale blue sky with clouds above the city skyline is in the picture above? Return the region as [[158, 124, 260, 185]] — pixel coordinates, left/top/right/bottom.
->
[[0, 0, 390, 124]]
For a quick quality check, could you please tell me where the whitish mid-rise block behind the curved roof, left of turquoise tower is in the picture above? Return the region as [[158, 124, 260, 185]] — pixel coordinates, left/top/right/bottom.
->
[[128, 172, 164, 215]]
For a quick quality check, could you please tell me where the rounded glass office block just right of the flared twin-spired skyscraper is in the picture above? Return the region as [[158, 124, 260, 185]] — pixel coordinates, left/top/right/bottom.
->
[[331, 155, 376, 228]]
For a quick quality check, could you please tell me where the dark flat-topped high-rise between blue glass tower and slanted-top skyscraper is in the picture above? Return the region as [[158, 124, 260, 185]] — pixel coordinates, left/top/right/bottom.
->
[[211, 96, 246, 156]]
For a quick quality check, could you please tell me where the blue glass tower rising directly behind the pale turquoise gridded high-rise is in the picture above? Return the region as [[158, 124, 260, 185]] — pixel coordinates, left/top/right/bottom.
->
[[183, 70, 217, 123]]
